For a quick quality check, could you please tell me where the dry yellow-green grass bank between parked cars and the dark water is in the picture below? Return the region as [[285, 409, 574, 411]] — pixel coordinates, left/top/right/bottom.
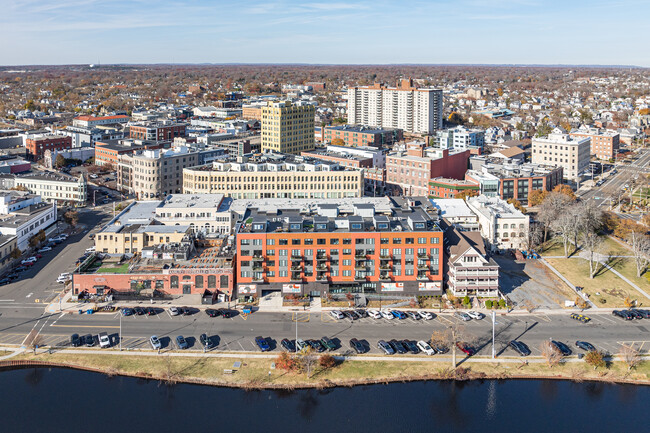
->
[[12, 352, 650, 389]]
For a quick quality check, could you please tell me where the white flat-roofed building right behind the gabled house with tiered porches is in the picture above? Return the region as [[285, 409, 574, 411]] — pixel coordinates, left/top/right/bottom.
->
[[467, 195, 530, 250]]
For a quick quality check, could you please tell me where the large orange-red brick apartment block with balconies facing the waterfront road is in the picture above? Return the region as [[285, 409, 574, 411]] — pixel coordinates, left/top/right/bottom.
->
[[236, 200, 443, 296]]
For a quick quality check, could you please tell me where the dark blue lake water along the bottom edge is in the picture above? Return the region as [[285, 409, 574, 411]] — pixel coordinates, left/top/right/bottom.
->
[[0, 368, 650, 433]]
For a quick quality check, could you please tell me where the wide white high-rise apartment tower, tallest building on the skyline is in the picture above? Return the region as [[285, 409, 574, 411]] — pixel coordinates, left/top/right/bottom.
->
[[348, 80, 442, 134]]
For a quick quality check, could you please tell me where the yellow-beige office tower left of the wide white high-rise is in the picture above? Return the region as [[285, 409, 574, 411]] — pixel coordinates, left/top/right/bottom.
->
[[262, 101, 315, 154]]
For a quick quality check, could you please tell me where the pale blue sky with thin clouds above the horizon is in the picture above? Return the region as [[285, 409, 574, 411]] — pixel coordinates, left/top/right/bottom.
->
[[0, 0, 650, 67]]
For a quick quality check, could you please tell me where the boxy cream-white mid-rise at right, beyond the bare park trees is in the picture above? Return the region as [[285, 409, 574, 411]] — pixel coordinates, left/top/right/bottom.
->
[[532, 128, 591, 180]]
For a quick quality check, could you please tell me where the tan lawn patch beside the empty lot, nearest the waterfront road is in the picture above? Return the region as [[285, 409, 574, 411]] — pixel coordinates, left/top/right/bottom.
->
[[546, 258, 645, 308]]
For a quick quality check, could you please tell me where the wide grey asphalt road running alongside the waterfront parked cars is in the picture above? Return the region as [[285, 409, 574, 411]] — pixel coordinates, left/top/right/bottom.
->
[[0, 306, 650, 356]]
